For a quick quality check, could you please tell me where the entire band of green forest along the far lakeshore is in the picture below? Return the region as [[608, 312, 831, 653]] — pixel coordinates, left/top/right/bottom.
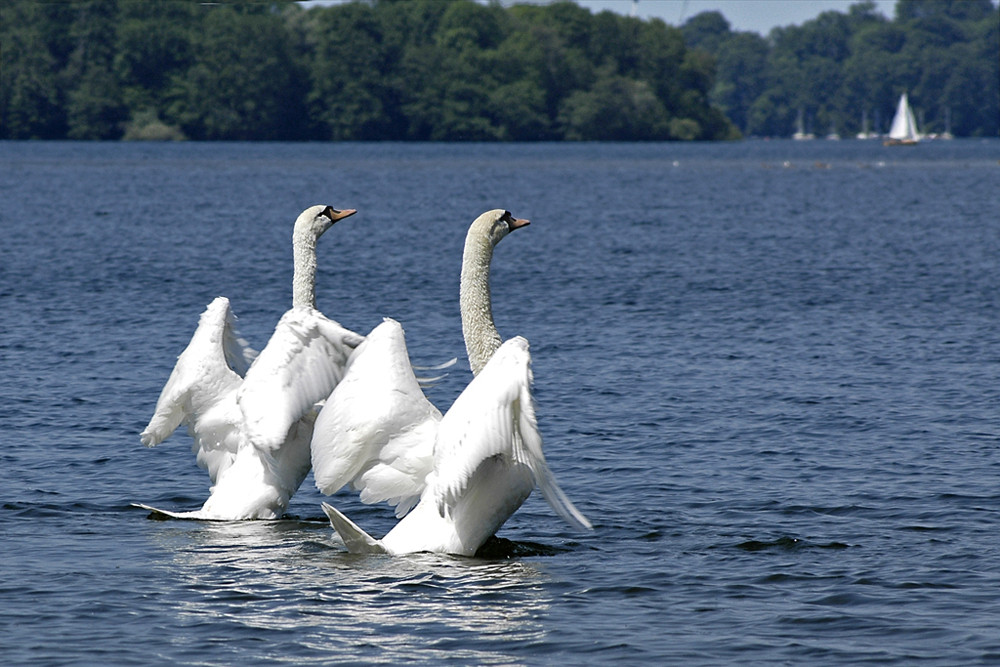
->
[[0, 0, 1000, 141]]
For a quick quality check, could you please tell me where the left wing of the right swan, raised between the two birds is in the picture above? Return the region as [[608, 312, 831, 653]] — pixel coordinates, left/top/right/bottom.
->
[[312, 318, 441, 517]]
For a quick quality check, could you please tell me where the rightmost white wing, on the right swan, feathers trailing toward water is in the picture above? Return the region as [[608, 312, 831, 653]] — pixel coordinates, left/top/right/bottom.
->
[[434, 337, 591, 528]]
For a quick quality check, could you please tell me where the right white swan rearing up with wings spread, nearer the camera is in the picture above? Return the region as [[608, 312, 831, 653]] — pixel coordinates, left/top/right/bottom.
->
[[311, 209, 591, 556]]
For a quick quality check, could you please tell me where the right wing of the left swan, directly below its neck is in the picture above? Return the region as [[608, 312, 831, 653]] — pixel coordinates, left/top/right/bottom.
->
[[236, 307, 364, 452]]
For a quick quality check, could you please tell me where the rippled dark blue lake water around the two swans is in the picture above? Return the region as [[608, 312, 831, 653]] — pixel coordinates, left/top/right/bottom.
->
[[0, 140, 1000, 665]]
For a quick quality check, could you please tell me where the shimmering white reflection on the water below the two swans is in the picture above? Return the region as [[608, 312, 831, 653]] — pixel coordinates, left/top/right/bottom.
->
[[145, 521, 550, 664]]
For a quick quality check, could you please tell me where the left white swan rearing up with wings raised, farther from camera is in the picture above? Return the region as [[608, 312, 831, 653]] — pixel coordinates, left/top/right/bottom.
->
[[140, 206, 364, 520]]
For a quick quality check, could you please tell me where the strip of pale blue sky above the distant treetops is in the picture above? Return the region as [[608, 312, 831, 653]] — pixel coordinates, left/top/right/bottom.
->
[[556, 0, 896, 35]]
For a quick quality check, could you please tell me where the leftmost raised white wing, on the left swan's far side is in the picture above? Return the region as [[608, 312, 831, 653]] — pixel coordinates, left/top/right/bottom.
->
[[140, 296, 256, 482]]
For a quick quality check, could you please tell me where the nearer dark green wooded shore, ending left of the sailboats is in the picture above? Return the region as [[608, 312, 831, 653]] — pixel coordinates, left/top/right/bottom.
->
[[0, 0, 735, 141]]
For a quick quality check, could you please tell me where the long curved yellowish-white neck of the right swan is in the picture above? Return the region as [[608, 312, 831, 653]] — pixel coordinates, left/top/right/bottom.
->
[[459, 230, 502, 375]]
